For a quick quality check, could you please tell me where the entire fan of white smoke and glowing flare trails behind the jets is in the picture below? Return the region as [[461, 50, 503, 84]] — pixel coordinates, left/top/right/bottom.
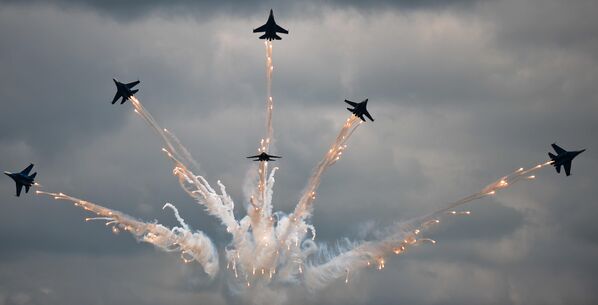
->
[[37, 37, 550, 300]]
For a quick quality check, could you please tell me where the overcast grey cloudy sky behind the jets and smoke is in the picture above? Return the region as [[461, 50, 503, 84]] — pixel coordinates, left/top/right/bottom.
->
[[0, 0, 598, 305]]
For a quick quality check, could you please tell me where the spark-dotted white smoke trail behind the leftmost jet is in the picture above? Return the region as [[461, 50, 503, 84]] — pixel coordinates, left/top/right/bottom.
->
[[36, 190, 219, 277]]
